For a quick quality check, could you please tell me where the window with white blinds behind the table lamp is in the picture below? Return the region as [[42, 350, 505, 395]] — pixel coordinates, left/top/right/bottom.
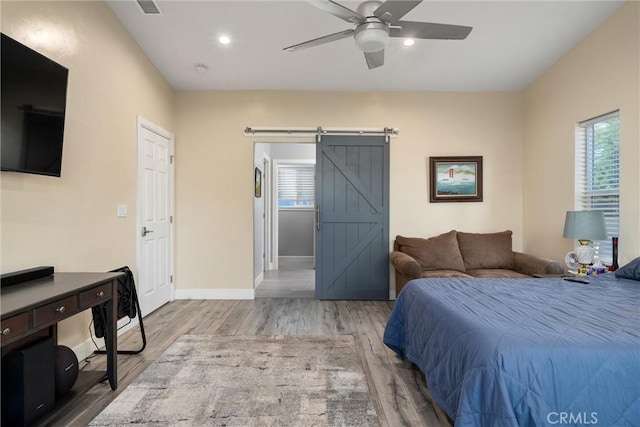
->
[[576, 111, 620, 262]]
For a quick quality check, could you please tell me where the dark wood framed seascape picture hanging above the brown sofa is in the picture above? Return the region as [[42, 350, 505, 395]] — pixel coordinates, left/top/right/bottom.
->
[[429, 156, 483, 203]]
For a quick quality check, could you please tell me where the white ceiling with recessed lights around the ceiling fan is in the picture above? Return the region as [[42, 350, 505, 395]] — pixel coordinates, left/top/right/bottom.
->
[[109, 0, 623, 91]]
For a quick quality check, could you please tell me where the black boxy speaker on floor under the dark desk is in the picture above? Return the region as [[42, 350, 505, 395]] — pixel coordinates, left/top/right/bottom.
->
[[2, 338, 56, 426]]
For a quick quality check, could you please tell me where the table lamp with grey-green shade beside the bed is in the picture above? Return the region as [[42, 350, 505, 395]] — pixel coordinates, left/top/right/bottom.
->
[[562, 211, 607, 276]]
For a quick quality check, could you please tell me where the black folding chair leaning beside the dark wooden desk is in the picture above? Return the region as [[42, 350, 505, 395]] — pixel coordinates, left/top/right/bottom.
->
[[91, 266, 147, 354]]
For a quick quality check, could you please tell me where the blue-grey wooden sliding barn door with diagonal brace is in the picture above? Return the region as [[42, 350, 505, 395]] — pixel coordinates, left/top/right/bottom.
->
[[316, 136, 389, 300]]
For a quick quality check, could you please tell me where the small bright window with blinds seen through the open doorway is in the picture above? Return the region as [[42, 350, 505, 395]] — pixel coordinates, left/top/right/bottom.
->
[[278, 164, 315, 208]]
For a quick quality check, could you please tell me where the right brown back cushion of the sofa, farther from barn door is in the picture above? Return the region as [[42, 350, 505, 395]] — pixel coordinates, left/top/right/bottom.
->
[[458, 230, 515, 270]]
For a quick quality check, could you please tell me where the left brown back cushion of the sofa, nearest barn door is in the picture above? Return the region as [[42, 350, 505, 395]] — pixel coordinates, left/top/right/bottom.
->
[[396, 230, 464, 271]]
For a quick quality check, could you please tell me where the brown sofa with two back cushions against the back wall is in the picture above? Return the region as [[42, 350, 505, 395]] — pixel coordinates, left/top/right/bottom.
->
[[390, 230, 564, 295]]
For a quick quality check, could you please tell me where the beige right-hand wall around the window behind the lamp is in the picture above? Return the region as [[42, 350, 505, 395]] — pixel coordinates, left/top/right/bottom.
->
[[523, 1, 640, 265]]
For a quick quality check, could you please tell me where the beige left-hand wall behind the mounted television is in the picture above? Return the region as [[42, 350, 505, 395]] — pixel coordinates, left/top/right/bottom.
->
[[1, 1, 173, 352]]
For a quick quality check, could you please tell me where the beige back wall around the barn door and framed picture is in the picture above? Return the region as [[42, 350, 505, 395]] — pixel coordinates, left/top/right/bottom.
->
[[176, 91, 522, 291]]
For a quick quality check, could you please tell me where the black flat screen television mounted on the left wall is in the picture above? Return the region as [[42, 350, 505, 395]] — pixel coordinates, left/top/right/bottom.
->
[[0, 34, 69, 176]]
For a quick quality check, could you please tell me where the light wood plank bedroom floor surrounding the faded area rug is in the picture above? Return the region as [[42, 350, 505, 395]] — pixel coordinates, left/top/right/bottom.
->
[[53, 298, 450, 427]]
